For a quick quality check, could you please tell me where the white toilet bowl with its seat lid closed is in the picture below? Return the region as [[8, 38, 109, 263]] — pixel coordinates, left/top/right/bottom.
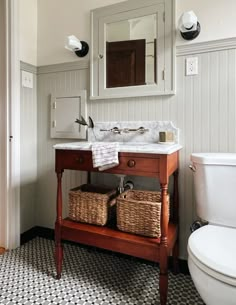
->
[[188, 225, 236, 305]]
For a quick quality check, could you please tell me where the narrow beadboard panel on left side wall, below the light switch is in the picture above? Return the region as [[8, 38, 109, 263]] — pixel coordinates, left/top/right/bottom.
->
[[20, 62, 37, 233]]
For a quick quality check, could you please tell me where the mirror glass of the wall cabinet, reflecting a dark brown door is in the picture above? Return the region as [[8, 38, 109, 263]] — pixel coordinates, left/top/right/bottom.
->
[[106, 14, 157, 88]]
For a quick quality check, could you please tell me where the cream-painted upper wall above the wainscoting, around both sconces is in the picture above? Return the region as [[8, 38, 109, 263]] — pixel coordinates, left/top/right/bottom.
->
[[20, 0, 236, 66]]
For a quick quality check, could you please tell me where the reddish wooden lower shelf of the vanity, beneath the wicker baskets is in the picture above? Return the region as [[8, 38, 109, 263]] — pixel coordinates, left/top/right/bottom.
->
[[61, 218, 178, 262]]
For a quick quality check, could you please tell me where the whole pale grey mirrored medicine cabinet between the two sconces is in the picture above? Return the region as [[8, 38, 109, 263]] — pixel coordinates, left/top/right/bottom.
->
[[90, 0, 175, 99]]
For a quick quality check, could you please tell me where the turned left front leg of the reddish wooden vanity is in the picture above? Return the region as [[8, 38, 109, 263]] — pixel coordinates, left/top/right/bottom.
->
[[55, 172, 63, 279]]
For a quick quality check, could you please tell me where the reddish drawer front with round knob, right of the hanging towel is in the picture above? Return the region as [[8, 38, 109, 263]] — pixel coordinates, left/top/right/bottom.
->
[[115, 156, 160, 173]]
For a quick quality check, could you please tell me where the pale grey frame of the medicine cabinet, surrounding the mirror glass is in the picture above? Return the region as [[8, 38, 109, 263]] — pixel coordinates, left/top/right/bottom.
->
[[90, 0, 176, 99]]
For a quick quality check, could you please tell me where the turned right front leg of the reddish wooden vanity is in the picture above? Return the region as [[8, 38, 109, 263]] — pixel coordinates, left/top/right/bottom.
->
[[159, 183, 169, 305]]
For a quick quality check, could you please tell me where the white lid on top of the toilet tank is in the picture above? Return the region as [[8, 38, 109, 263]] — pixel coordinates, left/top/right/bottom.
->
[[191, 153, 236, 165]]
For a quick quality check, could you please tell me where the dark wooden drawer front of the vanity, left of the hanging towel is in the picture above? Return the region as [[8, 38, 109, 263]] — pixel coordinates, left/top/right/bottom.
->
[[56, 150, 93, 171]]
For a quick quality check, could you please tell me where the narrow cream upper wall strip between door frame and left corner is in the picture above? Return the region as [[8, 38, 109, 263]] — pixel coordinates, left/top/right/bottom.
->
[[19, 0, 38, 66]]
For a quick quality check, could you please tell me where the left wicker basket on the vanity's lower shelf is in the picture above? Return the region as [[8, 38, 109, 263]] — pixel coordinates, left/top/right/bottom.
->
[[69, 184, 116, 226]]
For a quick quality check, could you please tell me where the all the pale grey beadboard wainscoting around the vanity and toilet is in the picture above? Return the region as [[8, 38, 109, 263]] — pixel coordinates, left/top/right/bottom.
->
[[21, 39, 236, 258]]
